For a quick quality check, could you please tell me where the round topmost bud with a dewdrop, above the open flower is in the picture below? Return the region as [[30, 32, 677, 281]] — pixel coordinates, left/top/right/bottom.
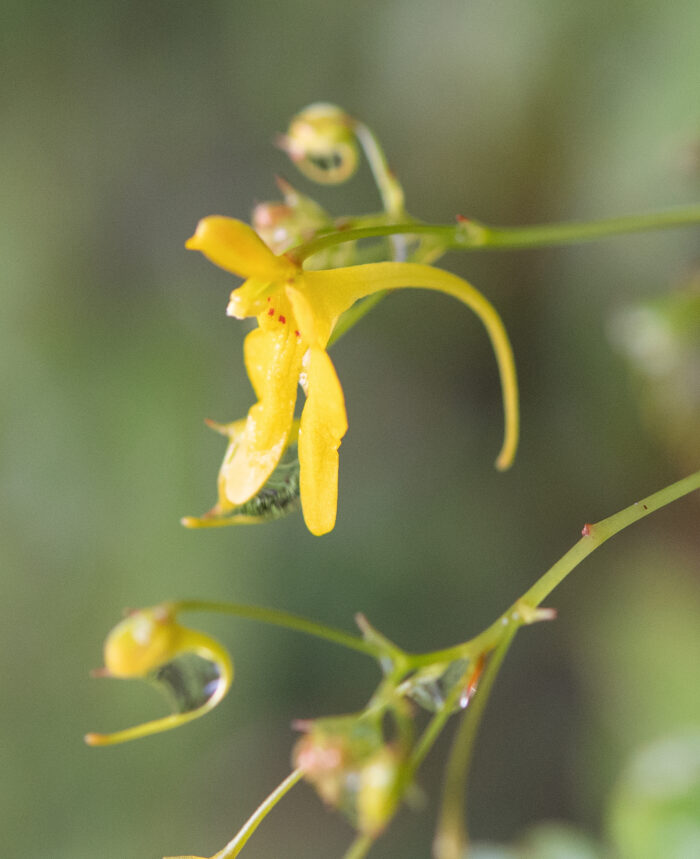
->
[[278, 102, 359, 185]]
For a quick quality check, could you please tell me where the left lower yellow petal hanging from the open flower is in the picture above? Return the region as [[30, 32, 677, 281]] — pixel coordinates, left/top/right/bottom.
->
[[221, 323, 304, 504]]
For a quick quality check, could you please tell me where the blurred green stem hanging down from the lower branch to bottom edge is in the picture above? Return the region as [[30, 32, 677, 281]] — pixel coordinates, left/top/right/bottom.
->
[[433, 623, 520, 859]]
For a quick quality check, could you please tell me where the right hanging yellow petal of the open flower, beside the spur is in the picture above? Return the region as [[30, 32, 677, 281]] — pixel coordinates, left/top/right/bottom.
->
[[299, 347, 348, 536]]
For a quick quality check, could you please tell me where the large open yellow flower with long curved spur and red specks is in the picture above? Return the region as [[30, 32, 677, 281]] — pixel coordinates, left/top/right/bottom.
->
[[186, 215, 518, 535]]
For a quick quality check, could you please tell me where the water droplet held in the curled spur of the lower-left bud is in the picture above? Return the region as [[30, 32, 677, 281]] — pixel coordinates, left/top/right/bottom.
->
[[148, 653, 226, 713]]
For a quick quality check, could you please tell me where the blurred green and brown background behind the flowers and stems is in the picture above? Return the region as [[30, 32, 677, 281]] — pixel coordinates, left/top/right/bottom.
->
[[0, 0, 700, 859]]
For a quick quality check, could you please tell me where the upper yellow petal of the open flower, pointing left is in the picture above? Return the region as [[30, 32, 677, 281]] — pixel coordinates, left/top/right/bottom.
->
[[185, 215, 297, 281]]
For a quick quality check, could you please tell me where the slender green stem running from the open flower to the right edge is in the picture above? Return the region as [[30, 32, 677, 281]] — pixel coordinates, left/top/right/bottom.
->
[[290, 205, 700, 261]]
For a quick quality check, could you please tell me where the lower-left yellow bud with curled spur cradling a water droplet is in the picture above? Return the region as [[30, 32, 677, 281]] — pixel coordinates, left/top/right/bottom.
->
[[85, 603, 233, 746]]
